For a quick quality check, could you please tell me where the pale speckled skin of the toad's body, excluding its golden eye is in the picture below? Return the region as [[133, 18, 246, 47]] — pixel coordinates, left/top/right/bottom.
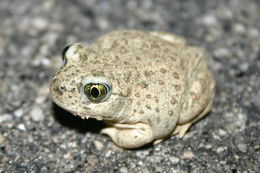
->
[[50, 30, 215, 148]]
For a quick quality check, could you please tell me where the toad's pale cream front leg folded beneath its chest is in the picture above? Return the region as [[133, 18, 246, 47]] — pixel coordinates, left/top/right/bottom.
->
[[101, 123, 154, 149]]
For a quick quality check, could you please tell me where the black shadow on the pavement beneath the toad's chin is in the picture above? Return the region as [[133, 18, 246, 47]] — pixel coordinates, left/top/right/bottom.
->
[[52, 103, 105, 133]]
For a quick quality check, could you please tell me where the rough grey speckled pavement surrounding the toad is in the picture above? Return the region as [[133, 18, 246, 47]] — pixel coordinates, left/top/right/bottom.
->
[[0, 0, 260, 173]]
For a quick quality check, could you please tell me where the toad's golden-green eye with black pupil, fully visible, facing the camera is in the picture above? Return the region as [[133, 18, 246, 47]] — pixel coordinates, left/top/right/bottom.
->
[[84, 83, 110, 102]]
